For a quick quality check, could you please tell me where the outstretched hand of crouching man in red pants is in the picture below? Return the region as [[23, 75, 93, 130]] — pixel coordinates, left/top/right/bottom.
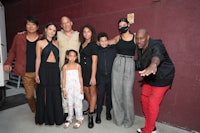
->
[[139, 64, 157, 77]]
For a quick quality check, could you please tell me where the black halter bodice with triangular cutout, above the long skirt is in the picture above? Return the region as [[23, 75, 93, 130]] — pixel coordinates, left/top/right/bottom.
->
[[41, 40, 59, 63]]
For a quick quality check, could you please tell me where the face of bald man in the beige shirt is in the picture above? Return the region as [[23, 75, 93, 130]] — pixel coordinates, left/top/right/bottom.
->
[[61, 17, 73, 32]]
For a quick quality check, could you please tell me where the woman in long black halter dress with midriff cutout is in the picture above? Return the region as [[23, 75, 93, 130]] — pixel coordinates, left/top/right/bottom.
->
[[35, 23, 63, 125]]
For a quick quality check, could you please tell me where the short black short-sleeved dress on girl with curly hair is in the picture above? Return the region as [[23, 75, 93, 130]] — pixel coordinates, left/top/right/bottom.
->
[[79, 42, 98, 87]]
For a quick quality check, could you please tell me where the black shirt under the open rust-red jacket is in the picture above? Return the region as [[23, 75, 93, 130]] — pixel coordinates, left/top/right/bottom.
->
[[26, 39, 37, 72]]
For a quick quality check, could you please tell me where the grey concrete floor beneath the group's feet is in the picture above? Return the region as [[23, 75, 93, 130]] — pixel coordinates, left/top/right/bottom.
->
[[0, 85, 193, 133]]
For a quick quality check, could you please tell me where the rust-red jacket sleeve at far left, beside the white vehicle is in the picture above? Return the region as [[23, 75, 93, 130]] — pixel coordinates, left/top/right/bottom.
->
[[4, 34, 19, 65]]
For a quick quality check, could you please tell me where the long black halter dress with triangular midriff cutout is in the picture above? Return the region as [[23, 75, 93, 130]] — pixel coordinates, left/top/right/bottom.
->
[[35, 41, 63, 125]]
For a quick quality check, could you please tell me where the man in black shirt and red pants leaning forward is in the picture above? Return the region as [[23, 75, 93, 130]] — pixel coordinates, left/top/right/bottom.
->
[[136, 29, 175, 133]]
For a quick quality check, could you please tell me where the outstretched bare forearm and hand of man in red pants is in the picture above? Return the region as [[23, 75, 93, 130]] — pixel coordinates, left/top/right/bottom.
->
[[139, 56, 160, 76]]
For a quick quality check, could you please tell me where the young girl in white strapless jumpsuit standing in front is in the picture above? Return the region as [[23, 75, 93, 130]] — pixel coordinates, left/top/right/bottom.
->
[[62, 49, 83, 128]]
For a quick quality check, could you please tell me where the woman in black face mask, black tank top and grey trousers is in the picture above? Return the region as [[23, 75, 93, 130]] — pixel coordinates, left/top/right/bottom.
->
[[109, 18, 136, 128]]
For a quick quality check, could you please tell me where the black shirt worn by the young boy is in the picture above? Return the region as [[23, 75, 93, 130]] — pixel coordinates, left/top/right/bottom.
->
[[97, 45, 116, 75]]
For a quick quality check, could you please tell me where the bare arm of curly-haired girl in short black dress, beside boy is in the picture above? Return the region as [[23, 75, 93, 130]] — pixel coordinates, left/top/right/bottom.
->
[[90, 55, 98, 85]]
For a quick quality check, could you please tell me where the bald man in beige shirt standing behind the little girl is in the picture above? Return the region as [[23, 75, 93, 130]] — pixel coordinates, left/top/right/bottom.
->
[[57, 16, 80, 120]]
